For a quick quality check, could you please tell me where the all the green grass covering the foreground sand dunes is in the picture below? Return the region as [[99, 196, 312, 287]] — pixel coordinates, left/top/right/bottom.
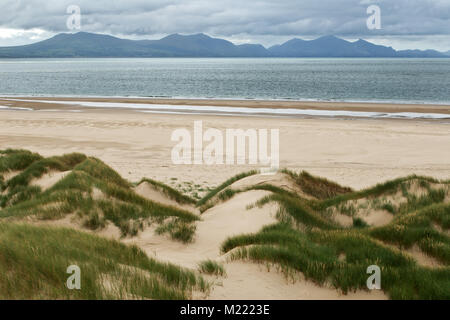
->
[[0, 149, 450, 299]]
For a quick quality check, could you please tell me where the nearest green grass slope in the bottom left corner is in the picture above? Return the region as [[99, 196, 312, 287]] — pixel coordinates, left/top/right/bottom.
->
[[0, 223, 209, 299]]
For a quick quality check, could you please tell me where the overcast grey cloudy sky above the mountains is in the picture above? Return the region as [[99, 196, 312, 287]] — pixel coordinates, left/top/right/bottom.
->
[[0, 0, 450, 51]]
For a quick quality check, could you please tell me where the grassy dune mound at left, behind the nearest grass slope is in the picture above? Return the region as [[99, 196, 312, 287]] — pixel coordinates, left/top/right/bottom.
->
[[0, 150, 198, 240]]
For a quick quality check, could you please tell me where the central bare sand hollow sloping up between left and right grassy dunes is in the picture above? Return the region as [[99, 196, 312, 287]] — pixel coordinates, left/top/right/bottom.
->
[[123, 190, 278, 268]]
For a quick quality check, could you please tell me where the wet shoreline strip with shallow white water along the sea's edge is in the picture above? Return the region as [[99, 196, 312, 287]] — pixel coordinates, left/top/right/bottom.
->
[[0, 97, 450, 120]]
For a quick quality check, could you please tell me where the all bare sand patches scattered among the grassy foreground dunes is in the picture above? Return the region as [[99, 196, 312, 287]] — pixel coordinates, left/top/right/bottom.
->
[[23, 172, 387, 300]]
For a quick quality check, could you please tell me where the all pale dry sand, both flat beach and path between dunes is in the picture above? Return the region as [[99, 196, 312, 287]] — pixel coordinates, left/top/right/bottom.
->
[[0, 100, 450, 299]]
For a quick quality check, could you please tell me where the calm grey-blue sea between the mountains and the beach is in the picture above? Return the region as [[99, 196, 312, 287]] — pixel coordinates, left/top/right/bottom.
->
[[0, 58, 450, 103]]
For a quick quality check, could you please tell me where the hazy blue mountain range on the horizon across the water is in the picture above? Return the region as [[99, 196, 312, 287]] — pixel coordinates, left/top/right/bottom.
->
[[0, 32, 450, 58]]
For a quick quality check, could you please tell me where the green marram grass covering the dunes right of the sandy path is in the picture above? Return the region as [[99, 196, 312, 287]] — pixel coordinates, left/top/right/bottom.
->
[[222, 174, 450, 299]]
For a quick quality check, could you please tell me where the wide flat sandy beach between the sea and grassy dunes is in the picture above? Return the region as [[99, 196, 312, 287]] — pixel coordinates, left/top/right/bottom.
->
[[0, 98, 450, 188]]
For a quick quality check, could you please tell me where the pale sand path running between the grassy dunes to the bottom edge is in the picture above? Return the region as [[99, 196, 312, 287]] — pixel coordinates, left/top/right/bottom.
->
[[122, 182, 387, 300]]
